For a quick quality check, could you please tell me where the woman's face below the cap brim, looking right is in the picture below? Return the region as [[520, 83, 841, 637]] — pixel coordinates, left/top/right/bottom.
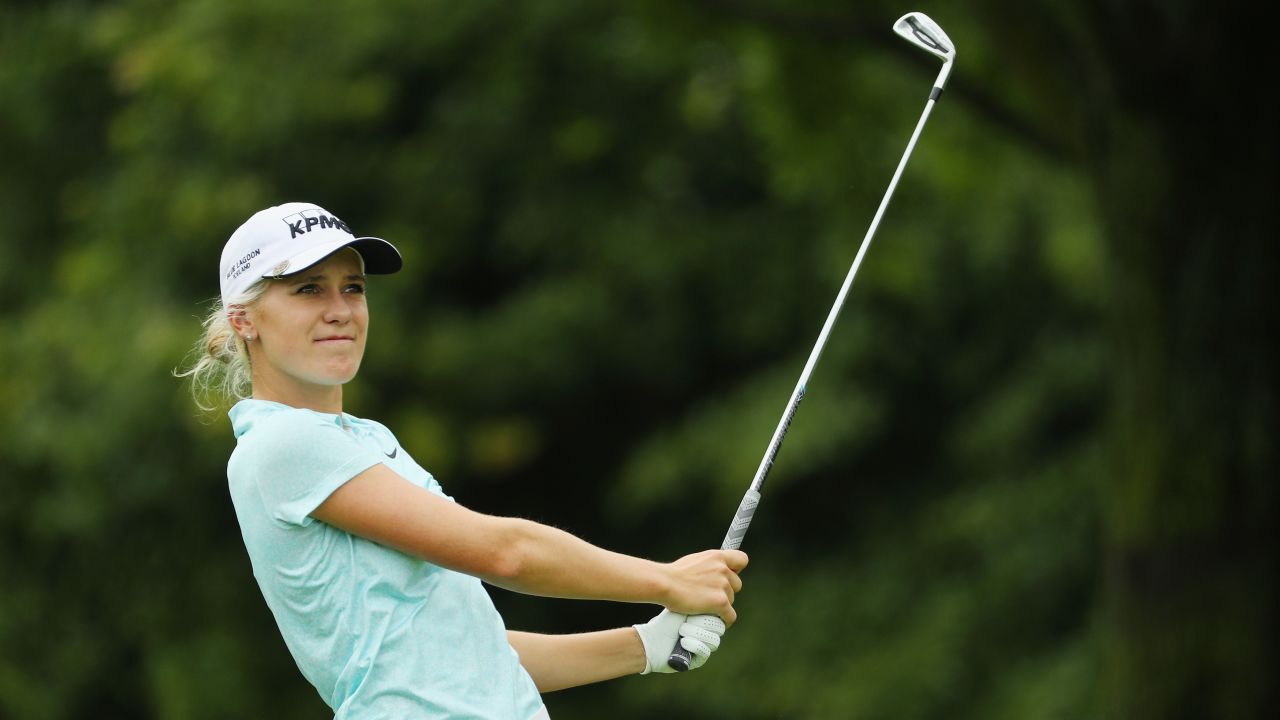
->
[[250, 247, 369, 389]]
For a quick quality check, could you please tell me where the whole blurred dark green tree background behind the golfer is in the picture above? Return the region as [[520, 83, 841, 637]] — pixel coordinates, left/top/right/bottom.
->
[[0, 0, 1276, 720]]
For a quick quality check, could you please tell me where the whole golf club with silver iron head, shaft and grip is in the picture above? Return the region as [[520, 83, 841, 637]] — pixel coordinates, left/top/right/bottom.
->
[[667, 13, 956, 673]]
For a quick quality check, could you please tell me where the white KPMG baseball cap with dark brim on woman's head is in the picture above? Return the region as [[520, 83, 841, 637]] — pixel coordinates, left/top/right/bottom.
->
[[218, 202, 403, 305]]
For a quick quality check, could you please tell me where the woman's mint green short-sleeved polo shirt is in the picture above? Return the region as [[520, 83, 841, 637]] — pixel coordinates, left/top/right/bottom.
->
[[227, 400, 547, 720]]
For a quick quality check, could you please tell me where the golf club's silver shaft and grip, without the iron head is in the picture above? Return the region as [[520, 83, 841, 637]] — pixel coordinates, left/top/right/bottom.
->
[[668, 90, 950, 671]]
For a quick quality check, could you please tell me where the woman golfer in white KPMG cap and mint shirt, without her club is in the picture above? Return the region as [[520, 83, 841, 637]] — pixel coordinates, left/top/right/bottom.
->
[[183, 202, 746, 720]]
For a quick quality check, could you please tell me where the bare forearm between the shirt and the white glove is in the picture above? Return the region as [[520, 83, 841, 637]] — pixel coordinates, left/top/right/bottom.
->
[[507, 628, 645, 693]]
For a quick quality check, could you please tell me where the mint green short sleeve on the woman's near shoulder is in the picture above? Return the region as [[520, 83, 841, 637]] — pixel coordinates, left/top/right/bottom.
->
[[241, 411, 383, 525]]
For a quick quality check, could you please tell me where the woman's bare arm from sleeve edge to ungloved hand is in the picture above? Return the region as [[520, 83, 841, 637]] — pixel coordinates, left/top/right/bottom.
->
[[311, 465, 746, 624]]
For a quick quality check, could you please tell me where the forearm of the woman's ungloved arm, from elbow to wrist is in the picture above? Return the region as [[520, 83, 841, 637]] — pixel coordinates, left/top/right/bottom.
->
[[485, 520, 671, 605]]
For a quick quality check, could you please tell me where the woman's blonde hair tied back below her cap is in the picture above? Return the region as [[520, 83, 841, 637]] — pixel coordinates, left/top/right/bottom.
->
[[173, 278, 270, 413]]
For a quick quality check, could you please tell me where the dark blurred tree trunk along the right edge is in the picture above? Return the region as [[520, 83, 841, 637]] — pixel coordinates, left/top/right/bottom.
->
[[1091, 3, 1280, 720]]
